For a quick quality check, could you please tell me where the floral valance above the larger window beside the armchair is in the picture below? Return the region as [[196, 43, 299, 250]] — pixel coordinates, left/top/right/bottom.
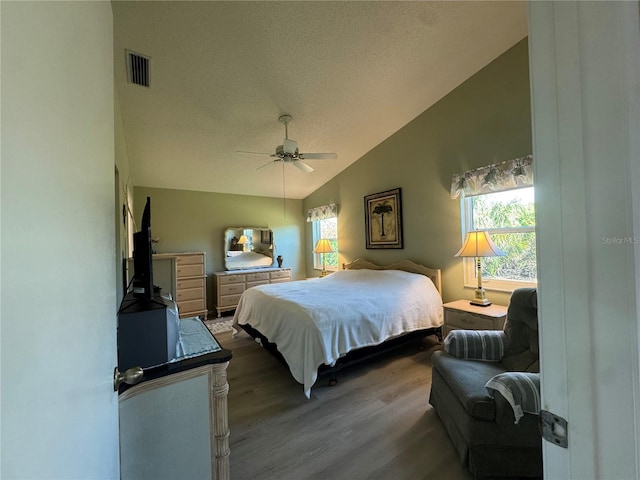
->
[[451, 155, 533, 198]]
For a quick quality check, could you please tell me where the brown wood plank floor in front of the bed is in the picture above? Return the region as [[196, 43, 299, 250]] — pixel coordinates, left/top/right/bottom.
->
[[216, 326, 472, 480]]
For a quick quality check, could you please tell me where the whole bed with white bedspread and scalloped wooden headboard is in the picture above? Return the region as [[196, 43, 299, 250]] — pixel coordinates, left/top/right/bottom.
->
[[233, 260, 443, 398]]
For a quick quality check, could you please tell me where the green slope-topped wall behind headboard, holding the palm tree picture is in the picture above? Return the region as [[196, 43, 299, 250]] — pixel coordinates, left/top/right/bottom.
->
[[304, 39, 532, 305]]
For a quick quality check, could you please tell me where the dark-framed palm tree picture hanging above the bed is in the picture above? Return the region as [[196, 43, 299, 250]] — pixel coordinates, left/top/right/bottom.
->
[[364, 188, 404, 249]]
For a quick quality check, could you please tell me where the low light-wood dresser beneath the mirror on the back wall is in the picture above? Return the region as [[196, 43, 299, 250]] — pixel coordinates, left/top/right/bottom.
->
[[213, 268, 291, 317]]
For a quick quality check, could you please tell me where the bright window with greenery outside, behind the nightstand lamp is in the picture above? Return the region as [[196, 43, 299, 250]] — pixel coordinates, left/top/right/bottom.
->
[[462, 187, 538, 291]]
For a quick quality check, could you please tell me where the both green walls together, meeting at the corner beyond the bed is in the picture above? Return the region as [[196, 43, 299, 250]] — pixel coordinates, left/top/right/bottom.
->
[[134, 39, 532, 310]]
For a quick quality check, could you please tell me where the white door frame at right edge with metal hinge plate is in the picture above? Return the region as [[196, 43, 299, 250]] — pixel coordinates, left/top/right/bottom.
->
[[529, 2, 640, 479]]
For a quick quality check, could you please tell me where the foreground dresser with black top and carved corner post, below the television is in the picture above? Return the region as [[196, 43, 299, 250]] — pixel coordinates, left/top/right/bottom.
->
[[118, 318, 231, 480]]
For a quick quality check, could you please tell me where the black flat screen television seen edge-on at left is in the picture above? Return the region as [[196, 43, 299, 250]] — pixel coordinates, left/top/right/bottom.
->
[[133, 197, 153, 300]]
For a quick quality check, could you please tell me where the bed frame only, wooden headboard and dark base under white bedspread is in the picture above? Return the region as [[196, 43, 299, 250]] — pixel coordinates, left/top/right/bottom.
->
[[240, 258, 442, 386]]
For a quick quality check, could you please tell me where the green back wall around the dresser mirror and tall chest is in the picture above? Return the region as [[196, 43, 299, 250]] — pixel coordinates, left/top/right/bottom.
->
[[134, 187, 306, 312]]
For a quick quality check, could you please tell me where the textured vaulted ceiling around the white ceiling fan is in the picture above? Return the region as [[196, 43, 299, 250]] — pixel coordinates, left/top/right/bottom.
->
[[112, 1, 527, 198]]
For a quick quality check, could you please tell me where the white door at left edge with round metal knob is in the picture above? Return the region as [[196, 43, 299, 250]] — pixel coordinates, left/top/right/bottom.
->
[[0, 2, 119, 479]]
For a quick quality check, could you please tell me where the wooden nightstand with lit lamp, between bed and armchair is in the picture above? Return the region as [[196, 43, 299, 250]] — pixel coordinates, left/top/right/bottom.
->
[[442, 300, 507, 337]]
